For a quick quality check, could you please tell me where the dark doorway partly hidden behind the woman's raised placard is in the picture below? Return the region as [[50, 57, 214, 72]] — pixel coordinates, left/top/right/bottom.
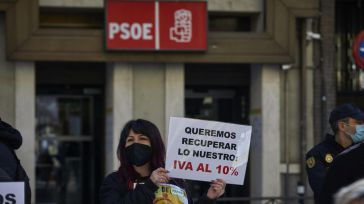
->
[[185, 64, 250, 204]]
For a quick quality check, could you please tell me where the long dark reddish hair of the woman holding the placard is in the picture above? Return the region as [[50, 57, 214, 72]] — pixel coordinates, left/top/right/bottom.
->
[[117, 119, 166, 190]]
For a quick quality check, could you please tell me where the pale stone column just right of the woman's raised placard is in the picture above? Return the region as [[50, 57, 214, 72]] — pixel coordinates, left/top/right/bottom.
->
[[250, 65, 281, 202]]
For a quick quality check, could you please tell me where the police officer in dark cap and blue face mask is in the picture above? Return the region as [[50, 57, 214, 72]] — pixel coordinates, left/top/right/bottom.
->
[[306, 104, 364, 203]]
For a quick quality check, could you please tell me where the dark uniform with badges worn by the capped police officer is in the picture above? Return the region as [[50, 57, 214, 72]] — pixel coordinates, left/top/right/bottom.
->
[[306, 134, 345, 203]]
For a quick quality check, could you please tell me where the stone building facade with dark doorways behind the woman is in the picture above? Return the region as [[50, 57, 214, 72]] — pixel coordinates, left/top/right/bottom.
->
[[0, 0, 319, 203]]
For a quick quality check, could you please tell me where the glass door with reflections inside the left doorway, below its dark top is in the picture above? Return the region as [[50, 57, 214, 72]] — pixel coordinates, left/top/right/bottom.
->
[[36, 95, 95, 204]]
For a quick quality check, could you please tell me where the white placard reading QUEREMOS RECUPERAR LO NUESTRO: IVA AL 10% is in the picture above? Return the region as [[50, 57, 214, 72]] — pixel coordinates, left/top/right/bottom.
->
[[166, 117, 252, 185]]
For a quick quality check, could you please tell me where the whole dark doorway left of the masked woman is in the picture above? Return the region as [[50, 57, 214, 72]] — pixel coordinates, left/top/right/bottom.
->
[[35, 63, 105, 204]]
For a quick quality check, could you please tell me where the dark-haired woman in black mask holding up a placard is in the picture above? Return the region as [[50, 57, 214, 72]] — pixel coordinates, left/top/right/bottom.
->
[[100, 119, 226, 204]]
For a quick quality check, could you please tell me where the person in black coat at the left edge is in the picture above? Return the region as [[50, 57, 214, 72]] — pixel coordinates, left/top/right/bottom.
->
[[0, 119, 31, 204]]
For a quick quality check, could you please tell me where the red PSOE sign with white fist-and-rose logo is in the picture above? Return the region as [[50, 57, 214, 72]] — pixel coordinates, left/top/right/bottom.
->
[[105, 0, 207, 51]]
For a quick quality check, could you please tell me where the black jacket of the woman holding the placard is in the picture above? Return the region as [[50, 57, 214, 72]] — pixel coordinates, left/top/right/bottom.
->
[[100, 173, 158, 204]]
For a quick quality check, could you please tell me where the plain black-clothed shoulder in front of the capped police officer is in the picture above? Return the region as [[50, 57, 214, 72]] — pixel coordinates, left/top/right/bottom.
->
[[319, 142, 364, 204]]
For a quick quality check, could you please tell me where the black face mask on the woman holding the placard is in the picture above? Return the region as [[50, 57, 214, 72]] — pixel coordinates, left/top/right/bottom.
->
[[126, 143, 152, 166]]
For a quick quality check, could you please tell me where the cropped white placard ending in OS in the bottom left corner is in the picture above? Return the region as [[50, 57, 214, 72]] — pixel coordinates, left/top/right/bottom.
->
[[0, 182, 25, 204]]
